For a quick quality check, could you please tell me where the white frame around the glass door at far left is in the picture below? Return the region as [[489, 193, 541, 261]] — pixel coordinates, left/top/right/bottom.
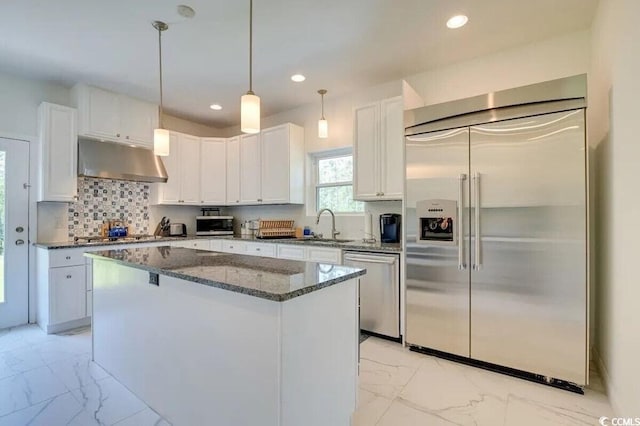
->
[[0, 130, 38, 324]]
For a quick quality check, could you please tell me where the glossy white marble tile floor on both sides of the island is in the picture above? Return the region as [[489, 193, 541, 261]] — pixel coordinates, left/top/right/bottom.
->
[[0, 325, 613, 426]]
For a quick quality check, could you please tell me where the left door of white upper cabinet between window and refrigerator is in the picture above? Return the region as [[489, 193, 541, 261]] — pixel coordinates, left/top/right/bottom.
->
[[353, 103, 380, 200]]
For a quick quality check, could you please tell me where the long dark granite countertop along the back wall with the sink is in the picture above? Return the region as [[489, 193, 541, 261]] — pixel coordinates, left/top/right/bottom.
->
[[35, 235, 402, 253]]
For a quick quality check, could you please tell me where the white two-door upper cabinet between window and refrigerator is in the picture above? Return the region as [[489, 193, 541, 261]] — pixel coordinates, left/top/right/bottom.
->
[[353, 96, 404, 200]]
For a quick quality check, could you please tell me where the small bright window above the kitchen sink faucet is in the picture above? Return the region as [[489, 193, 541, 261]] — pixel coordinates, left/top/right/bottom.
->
[[315, 153, 364, 213]]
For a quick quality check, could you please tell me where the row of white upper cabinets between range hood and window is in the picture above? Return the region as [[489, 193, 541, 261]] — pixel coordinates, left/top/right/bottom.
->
[[157, 123, 304, 206]]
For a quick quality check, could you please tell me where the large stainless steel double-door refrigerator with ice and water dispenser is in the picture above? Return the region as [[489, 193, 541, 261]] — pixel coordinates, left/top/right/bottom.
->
[[405, 76, 589, 386]]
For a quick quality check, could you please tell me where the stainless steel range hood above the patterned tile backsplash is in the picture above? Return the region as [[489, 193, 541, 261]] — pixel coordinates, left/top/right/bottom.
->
[[78, 139, 168, 182]]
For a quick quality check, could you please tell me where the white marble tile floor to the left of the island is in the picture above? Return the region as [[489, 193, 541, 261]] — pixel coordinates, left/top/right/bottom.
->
[[0, 325, 169, 426]]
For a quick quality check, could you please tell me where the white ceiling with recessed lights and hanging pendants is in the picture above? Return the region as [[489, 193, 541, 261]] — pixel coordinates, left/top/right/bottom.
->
[[0, 0, 598, 127]]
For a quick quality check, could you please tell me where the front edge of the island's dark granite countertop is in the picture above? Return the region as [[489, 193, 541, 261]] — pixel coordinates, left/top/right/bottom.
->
[[84, 252, 366, 302]]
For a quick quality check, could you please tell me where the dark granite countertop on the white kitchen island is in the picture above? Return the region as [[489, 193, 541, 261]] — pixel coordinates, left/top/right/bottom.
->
[[85, 246, 366, 302]]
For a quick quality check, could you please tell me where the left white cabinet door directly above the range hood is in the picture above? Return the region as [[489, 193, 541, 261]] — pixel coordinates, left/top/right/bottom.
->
[[81, 87, 121, 141]]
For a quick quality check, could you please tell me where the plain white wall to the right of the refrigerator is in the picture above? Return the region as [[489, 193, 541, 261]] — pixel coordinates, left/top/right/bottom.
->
[[589, 0, 640, 417]]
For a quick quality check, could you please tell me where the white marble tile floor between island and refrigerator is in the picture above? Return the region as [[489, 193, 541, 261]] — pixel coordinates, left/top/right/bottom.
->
[[354, 337, 613, 426]]
